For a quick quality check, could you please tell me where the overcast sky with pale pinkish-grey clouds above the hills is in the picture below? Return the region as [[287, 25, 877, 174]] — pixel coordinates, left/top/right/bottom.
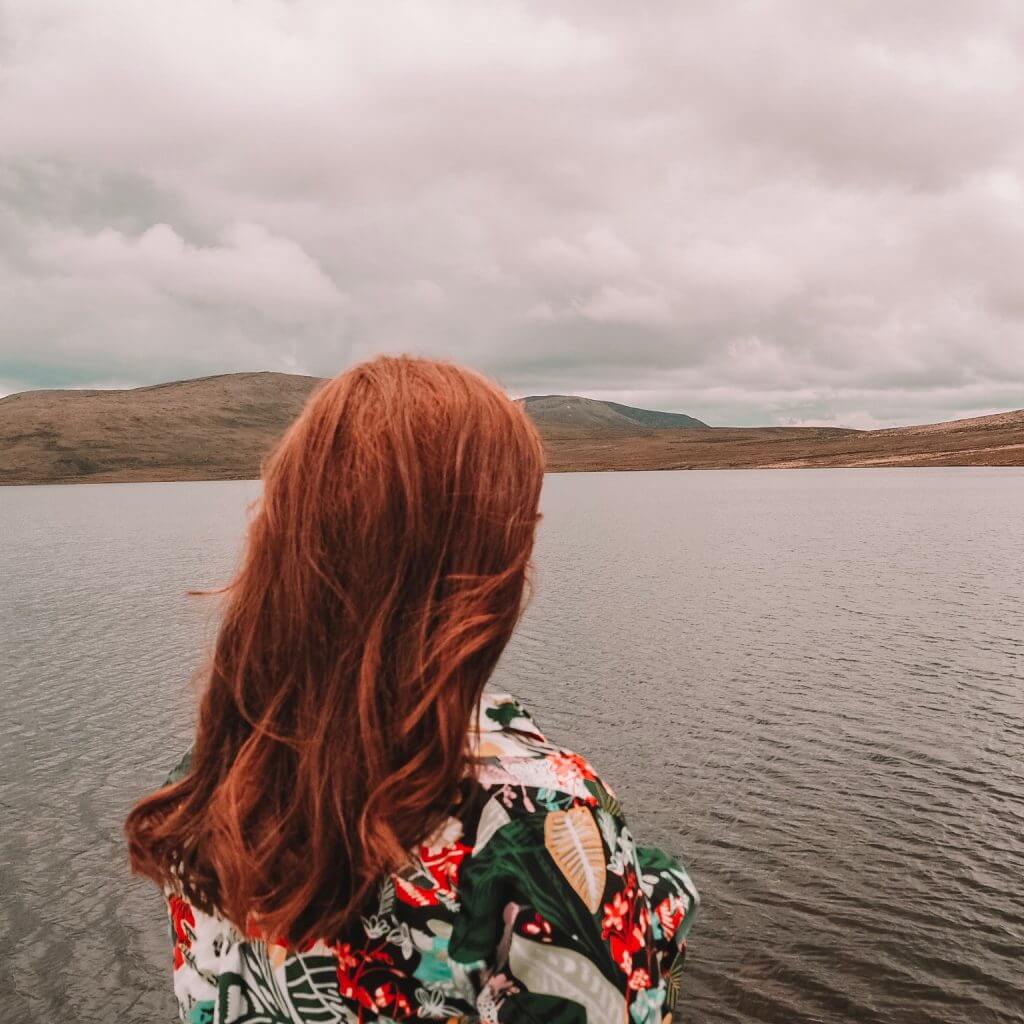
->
[[0, 0, 1024, 427]]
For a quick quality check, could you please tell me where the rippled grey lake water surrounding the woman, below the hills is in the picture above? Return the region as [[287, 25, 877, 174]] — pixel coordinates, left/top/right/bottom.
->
[[0, 469, 1024, 1024]]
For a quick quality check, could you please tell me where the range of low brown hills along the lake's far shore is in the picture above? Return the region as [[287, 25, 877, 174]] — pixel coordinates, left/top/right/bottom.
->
[[0, 373, 1024, 484]]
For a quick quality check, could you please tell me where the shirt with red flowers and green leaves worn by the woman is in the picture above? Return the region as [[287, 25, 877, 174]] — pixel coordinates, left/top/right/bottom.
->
[[167, 692, 698, 1024]]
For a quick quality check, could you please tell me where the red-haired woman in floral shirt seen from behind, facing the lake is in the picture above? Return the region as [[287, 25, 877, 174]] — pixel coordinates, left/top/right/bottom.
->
[[126, 356, 697, 1024]]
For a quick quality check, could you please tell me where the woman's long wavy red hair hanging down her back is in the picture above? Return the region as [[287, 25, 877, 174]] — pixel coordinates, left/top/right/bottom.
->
[[125, 355, 544, 945]]
